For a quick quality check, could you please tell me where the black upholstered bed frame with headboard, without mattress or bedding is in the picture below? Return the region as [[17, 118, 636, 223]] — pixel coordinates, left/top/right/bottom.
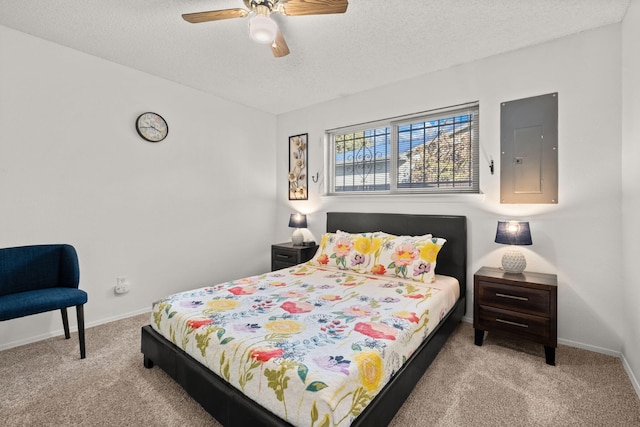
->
[[142, 212, 467, 427]]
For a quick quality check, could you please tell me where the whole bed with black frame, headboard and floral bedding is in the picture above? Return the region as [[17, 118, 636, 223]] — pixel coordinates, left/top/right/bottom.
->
[[142, 212, 467, 426]]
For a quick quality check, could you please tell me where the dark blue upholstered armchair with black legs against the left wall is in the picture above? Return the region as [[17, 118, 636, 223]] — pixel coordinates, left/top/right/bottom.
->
[[0, 245, 87, 359]]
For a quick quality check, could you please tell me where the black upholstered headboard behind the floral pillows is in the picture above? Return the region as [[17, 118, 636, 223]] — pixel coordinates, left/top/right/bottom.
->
[[327, 212, 467, 298]]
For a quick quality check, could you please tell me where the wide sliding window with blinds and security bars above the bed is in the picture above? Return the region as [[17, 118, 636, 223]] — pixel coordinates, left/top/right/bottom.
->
[[327, 103, 480, 194]]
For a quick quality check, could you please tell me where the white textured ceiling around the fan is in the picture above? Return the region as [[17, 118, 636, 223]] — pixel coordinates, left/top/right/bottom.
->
[[0, 0, 631, 114]]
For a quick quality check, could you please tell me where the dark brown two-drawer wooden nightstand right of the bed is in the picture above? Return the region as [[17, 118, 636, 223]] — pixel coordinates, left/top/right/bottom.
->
[[473, 267, 558, 365]]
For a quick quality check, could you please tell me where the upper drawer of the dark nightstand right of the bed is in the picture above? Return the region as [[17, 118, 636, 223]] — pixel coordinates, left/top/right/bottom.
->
[[474, 280, 550, 317]]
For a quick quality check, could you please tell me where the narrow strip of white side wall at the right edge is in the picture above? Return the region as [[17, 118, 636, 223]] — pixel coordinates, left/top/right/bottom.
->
[[622, 0, 640, 395]]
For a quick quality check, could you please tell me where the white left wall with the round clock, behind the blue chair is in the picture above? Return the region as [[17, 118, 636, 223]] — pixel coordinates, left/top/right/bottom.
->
[[0, 26, 276, 348]]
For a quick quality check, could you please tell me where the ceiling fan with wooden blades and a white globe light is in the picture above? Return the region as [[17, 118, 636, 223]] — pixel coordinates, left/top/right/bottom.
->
[[182, 0, 349, 58]]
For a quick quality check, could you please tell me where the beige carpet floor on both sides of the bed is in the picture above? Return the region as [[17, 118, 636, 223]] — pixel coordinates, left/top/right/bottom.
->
[[0, 315, 640, 427]]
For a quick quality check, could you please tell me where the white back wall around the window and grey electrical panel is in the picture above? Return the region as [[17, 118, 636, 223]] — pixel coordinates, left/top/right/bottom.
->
[[277, 25, 624, 353]]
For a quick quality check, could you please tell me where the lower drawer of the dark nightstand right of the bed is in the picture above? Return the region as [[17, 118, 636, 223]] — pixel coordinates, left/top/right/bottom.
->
[[477, 305, 555, 345]]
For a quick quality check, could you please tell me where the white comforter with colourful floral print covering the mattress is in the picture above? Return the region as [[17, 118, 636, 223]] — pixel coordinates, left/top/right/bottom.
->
[[152, 264, 459, 427]]
